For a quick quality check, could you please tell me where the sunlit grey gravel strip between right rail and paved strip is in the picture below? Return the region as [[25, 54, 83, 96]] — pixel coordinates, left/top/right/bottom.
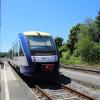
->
[[67, 80, 100, 100]]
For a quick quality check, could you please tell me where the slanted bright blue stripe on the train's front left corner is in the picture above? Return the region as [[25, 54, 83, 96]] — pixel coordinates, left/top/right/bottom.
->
[[18, 33, 32, 65]]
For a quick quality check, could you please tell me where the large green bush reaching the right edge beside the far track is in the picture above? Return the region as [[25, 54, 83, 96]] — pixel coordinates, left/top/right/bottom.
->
[[76, 33, 100, 63]]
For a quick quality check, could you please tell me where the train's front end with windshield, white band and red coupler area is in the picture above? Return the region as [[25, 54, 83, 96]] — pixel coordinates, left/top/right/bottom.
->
[[24, 32, 60, 80]]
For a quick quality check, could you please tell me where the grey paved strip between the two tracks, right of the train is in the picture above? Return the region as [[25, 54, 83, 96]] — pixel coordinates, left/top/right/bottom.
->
[[60, 68, 100, 87]]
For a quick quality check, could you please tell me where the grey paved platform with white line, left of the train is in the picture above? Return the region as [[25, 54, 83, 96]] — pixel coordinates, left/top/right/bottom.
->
[[0, 62, 37, 100]]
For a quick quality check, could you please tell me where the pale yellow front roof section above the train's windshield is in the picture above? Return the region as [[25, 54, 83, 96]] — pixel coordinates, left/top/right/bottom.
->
[[23, 31, 51, 36]]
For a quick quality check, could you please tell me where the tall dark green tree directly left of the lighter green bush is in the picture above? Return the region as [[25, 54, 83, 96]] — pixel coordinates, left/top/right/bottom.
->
[[67, 24, 82, 54]]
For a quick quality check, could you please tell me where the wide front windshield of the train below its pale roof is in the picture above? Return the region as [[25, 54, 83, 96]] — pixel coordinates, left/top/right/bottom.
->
[[27, 36, 55, 48]]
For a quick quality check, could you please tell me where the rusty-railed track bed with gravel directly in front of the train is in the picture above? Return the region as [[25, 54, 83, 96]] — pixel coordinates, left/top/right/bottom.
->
[[32, 81, 95, 100]]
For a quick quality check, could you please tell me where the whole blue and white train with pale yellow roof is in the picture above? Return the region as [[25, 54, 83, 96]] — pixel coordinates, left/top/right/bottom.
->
[[9, 31, 60, 80]]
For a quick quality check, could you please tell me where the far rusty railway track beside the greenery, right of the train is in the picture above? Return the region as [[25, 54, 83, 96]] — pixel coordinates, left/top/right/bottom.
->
[[61, 65, 100, 74]]
